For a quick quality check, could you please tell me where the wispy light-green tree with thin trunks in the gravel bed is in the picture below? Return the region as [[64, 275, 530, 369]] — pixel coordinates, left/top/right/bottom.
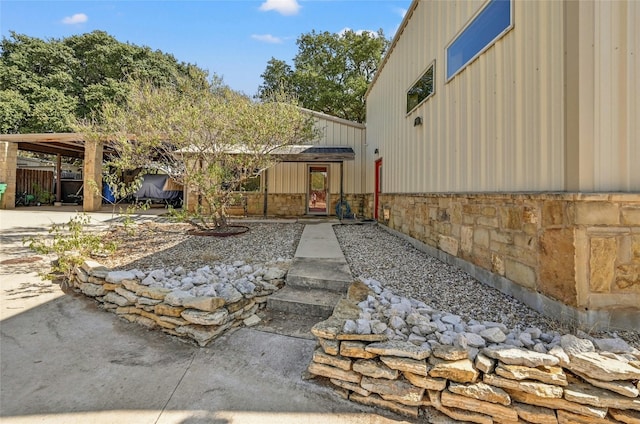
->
[[77, 78, 314, 229]]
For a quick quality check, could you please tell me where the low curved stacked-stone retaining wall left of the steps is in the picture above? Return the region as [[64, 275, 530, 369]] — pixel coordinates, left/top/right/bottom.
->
[[70, 261, 286, 346]]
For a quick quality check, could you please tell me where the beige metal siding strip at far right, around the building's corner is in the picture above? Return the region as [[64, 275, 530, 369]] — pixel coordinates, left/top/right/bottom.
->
[[592, 1, 640, 191]]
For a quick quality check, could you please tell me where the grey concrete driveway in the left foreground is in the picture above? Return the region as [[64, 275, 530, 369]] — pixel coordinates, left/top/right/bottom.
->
[[0, 208, 407, 424]]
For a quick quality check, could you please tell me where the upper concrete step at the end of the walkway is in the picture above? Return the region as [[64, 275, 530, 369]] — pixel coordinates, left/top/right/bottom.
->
[[287, 257, 353, 293]]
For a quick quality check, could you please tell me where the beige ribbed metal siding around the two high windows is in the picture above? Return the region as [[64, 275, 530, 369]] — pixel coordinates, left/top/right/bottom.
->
[[367, 0, 564, 193]]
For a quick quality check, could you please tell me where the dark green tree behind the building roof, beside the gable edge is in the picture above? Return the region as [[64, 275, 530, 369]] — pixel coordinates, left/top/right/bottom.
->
[[258, 30, 389, 122]]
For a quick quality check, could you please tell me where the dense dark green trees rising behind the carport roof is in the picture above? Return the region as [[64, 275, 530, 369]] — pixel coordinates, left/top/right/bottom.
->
[[0, 31, 207, 134]]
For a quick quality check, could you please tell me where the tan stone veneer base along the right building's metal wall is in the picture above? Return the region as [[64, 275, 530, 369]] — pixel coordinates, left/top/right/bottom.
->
[[379, 193, 640, 329]]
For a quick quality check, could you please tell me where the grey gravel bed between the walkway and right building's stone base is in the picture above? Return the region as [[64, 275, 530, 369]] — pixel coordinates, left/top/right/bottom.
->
[[334, 225, 640, 349]]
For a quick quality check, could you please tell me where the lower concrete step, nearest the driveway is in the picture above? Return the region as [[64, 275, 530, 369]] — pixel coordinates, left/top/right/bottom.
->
[[267, 286, 342, 321]]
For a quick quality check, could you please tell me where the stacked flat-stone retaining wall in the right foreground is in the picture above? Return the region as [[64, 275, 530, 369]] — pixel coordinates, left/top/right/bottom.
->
[[308, 283, 640, 424]]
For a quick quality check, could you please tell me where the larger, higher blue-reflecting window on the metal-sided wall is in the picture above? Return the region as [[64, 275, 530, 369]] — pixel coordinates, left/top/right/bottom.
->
[[446, 0, 513, 81]]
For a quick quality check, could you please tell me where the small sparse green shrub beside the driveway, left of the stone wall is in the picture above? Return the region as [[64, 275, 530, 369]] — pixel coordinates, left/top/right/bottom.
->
[[24, 214, 117, 281]]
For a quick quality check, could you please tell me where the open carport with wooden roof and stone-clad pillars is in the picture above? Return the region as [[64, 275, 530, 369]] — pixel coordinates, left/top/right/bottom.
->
[[0, 133, 110, 212]]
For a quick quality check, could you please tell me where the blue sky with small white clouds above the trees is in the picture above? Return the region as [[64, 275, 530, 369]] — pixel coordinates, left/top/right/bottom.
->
[[0, 0, 411, 95]]
